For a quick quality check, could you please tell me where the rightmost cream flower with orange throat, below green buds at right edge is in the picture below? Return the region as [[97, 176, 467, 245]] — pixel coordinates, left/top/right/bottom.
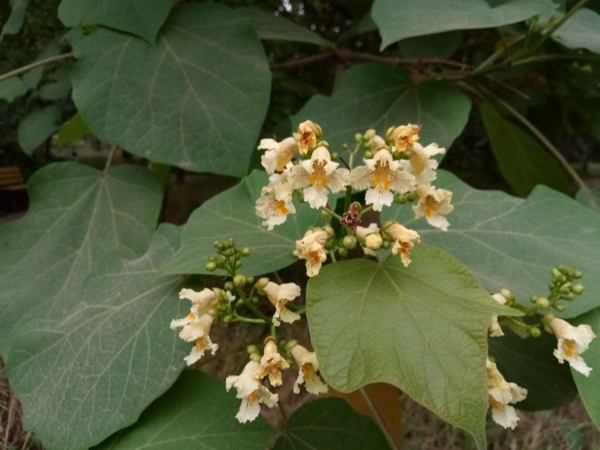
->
[[548, 318, 596, 377]]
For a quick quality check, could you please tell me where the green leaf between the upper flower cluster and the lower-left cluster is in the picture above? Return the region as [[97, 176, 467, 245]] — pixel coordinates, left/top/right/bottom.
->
[[161, 171, 321, 275]]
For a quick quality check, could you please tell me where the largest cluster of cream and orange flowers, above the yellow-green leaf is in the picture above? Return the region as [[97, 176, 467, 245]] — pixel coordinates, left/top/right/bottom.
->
[[256, 120, 454, 277]]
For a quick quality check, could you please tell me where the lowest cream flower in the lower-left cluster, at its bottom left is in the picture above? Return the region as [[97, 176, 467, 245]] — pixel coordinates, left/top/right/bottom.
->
[[225, 361, 279, 423]]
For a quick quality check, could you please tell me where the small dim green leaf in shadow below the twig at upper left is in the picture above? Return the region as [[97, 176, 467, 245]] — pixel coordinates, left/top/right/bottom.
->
[[17, 105, 61, 155]]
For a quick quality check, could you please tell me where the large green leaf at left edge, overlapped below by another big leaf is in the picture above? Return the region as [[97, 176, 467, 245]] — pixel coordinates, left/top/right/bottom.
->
[[0, 163, 162, 350]]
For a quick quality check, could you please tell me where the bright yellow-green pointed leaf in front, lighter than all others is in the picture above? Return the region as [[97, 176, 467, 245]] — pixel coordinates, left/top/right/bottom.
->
[[307, 245, 519, 448]]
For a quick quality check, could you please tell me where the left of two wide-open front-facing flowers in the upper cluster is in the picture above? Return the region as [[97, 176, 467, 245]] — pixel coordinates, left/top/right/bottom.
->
[[290, 147, 350, 209]]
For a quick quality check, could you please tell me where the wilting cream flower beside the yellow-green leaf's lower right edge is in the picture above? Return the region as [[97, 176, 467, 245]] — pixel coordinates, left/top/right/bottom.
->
[[486, 359, 527, 429]]
